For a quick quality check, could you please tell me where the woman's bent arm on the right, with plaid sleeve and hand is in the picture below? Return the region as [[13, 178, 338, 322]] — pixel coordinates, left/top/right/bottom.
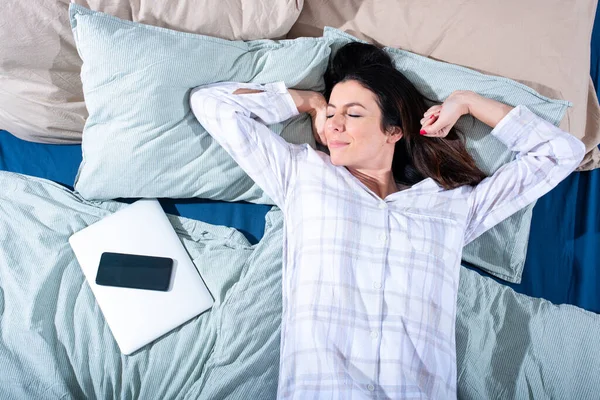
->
[[421, 91, 585, 245]]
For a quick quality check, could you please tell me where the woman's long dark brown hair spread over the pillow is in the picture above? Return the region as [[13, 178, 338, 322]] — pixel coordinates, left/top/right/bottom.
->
[[325, 42, 486, 190]]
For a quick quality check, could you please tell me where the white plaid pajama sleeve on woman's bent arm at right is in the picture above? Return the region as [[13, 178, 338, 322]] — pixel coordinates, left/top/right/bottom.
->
[[464, 106, 585, 245]]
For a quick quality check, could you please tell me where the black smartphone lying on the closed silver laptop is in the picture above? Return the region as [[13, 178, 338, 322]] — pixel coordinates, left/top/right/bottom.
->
[[96, 252, 173, 292]]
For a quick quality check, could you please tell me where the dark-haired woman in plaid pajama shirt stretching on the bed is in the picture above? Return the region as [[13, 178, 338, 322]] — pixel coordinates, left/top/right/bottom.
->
[[190, 44, 585, 399]]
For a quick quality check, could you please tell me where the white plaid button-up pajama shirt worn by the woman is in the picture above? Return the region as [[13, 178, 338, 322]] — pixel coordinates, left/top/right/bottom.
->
[[190, 82, 585, 399]]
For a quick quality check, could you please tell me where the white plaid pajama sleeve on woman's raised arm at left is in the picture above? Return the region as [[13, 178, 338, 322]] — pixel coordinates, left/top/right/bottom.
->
[[190, 82, 298, 208]]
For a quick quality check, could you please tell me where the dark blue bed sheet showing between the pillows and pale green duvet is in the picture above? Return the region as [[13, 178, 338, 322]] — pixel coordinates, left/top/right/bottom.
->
[[0, 7, 600, 313]]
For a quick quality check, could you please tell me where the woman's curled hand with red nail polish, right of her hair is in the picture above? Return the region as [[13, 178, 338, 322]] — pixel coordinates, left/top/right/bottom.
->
[[421, 91, 469, 137]]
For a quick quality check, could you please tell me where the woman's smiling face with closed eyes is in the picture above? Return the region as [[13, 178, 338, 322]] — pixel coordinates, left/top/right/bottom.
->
[[325, 80, 402, 170]]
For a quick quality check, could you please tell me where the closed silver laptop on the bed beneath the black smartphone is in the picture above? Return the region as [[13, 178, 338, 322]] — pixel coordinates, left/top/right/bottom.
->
[[69, 199, 213, 355]]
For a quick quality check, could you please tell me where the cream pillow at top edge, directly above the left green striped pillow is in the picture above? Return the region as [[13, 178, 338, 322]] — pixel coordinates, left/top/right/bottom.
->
[[72, 0, 304, 40]]
